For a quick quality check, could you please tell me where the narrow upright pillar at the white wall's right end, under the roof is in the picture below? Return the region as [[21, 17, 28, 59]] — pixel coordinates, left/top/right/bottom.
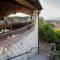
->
[[32, 10, 38, 52]]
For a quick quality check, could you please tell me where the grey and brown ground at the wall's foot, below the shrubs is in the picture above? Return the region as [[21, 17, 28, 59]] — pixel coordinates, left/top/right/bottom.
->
[[31, 40, 50, 60]]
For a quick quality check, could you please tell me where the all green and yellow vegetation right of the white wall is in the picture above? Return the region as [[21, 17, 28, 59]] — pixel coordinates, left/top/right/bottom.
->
[[38, 18, 60, 60]]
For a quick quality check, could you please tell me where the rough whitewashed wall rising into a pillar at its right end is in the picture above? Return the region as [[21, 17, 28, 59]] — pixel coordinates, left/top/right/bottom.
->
[[0, 11, 38, 60]]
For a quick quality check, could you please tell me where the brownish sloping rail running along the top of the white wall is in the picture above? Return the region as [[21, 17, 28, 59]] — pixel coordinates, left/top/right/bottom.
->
[[0, 23, 34, 38]]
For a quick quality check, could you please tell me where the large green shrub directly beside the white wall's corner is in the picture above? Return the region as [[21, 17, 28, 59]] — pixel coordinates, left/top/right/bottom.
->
[[38, 19, 58, 42]]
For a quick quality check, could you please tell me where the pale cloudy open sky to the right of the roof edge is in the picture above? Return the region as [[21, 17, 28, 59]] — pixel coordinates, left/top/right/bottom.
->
[[39, 0, 60, 19]]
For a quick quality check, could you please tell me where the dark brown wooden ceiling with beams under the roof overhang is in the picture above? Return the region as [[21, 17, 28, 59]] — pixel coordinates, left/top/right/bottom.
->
[[0, 0, 42, 17]]
